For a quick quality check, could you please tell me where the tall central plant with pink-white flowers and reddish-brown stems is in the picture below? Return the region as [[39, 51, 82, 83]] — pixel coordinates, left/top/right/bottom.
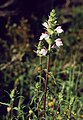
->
[[36, 9, 63, 117]]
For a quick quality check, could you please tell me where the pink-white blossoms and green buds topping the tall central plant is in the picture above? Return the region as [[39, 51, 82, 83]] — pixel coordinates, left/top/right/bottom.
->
[[37, 9, 63, 56]]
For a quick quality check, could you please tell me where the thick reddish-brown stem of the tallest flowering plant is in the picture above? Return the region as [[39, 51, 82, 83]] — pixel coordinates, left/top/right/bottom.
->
[[44, 45, 50, 117]]
